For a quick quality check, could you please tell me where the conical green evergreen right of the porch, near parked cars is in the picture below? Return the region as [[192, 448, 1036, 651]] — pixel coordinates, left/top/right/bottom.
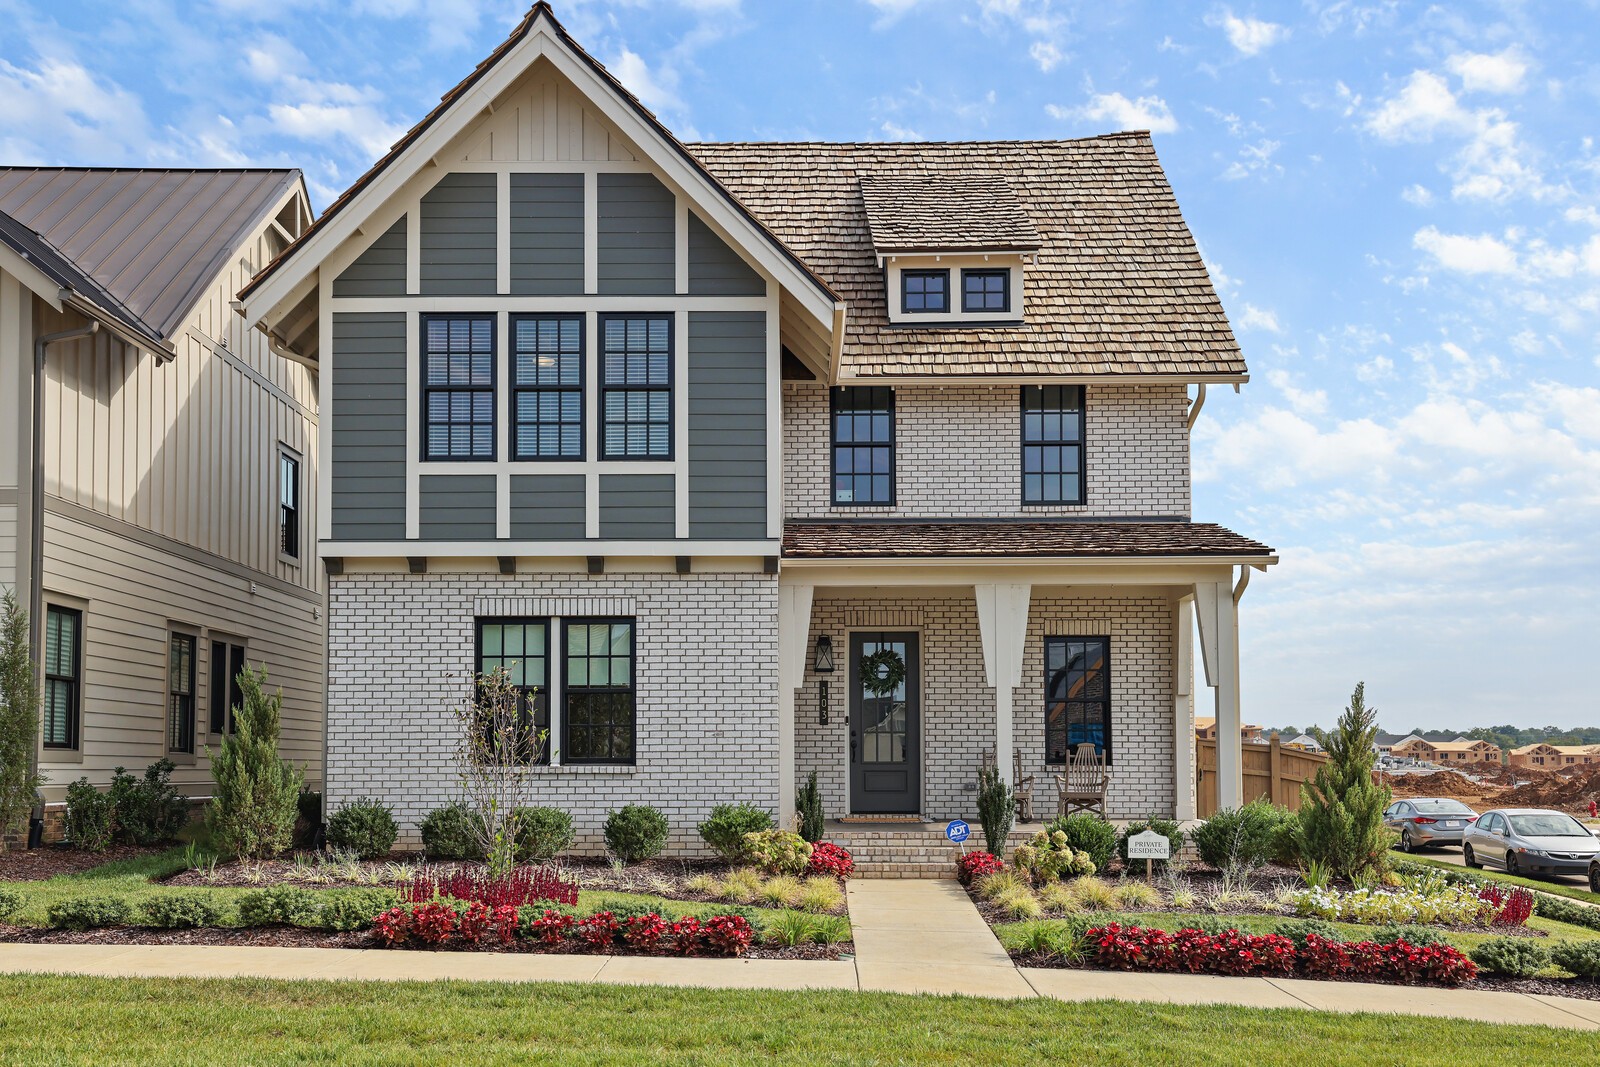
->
[[1298, 681, 1389, 878]]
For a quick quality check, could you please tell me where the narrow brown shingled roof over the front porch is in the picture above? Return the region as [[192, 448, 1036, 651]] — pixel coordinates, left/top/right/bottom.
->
[[784, 520, 1272, 560]]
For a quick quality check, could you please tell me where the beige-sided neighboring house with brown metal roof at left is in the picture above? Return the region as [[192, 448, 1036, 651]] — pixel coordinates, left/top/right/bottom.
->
[[0, 166, 325, 831]]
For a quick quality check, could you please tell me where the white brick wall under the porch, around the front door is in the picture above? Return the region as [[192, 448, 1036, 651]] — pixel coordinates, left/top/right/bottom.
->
[[795, 589, 1176, 819]]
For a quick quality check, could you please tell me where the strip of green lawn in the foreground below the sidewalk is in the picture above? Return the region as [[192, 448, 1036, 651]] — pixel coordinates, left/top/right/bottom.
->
[[0, 976, 1594, 1067]]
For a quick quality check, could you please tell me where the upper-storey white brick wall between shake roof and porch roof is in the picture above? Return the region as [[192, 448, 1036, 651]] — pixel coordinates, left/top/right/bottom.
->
[[784, 382, 1189, 520]]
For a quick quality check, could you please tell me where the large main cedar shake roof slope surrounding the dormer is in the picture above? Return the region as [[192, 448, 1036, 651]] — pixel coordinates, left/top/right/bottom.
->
[[688, 133, 1246, 381]]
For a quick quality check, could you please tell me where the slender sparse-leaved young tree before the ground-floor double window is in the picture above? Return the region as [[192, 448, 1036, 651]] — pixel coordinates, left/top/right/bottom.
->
[[451, 667, 550, 877]]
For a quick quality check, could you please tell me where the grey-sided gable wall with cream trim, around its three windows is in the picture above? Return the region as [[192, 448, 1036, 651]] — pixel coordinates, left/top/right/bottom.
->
[[320, 61, 782, 558]]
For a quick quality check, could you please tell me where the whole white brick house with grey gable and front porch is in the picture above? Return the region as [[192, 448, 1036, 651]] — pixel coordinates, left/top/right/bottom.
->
[[240, 3, 1275, 851]]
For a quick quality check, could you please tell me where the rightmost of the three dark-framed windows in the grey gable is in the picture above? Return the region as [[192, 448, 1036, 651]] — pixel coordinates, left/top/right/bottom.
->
[[600, 315, 672, 459]]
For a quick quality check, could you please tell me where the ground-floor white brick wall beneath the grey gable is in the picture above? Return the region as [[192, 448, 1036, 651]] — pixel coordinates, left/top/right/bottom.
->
[[325, 573, 778, 853]]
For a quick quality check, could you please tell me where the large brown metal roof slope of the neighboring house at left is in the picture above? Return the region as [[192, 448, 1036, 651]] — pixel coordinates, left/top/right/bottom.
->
[[0, 166, 299, 338]]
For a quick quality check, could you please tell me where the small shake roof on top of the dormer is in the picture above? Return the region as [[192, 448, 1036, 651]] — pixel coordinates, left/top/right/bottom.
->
[[861, 173, 1043, 254]]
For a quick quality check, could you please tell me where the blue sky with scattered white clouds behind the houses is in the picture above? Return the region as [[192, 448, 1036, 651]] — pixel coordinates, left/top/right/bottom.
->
[[0, 0, 1600, 728]]
